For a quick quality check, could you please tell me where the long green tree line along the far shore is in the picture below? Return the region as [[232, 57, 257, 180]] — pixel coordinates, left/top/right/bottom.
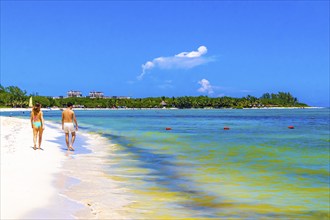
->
[[0, 85, 309, 109]]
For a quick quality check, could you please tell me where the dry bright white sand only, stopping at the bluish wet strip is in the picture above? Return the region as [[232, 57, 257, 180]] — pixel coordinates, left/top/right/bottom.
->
[[1, 117, 65, 219]]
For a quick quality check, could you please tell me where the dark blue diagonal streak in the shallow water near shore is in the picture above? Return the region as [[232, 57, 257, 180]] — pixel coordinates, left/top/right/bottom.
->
[[102, 131, 232, 218]]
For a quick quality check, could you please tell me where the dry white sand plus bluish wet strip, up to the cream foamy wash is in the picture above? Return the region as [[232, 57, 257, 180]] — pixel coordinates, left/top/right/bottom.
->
[[0, 116, 93, 219]]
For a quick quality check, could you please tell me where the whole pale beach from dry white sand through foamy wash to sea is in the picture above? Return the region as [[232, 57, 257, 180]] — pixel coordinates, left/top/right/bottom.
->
[[0, 116, 133, 219]]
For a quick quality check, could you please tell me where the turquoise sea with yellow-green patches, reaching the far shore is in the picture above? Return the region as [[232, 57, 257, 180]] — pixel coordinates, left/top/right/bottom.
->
[[2, 108, 330, 218]]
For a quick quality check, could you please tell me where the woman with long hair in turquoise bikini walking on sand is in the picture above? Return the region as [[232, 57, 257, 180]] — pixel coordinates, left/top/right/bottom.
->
[[31, 103, 45, 150]]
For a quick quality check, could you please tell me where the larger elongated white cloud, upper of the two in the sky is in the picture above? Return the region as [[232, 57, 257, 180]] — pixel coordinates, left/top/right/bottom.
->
[[137, 46, 212, 80]]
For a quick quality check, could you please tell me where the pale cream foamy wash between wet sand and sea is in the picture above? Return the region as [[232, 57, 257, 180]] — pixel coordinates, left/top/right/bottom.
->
[[60, 133, 137, 219]]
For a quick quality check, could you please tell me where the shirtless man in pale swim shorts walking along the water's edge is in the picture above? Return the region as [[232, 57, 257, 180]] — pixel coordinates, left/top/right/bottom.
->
[[62, 102, 78, 151]]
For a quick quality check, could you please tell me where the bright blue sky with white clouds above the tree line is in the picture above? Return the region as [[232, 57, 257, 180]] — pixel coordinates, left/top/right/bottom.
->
[[1, 1, 329, 106]]
